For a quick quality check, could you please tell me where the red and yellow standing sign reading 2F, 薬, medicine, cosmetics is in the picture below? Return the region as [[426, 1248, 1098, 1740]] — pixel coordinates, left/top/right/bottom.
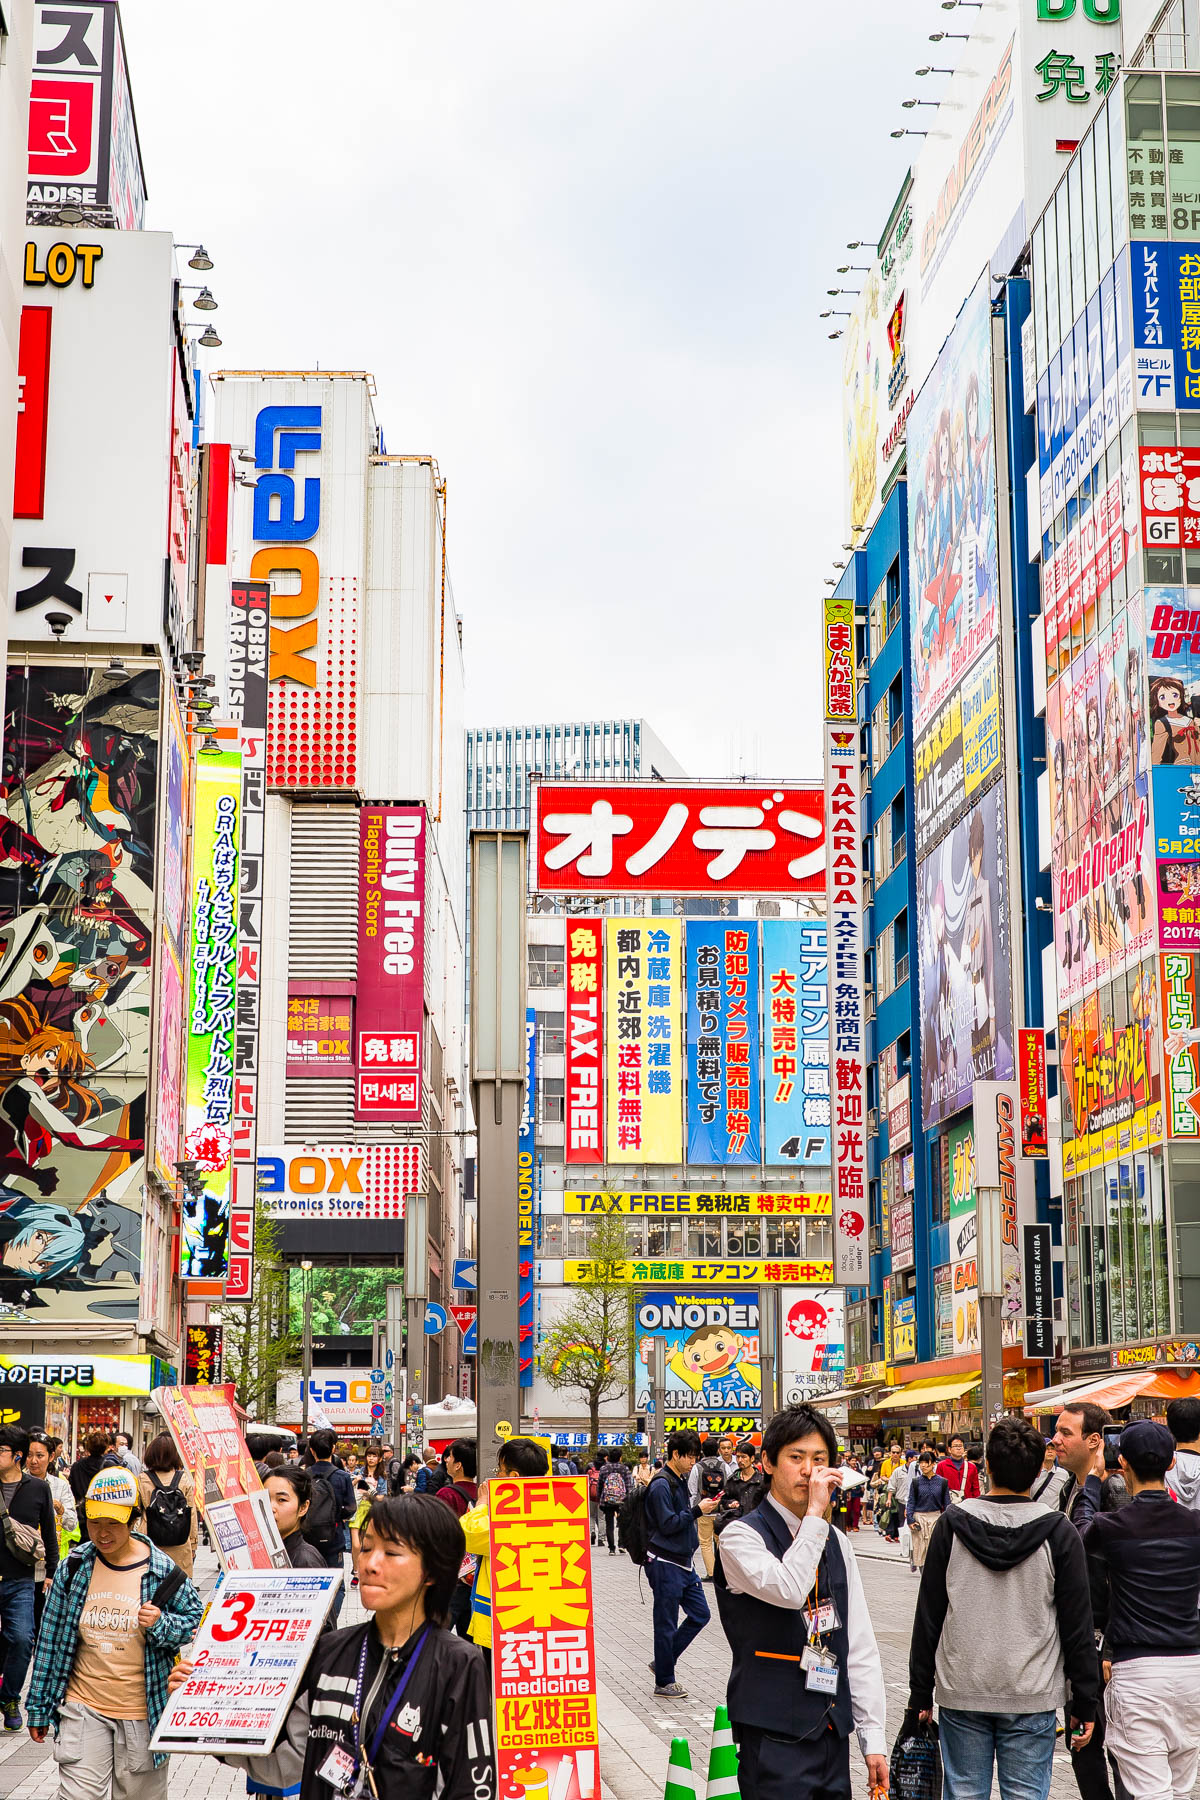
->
[[488, 1480, 599, 1800]]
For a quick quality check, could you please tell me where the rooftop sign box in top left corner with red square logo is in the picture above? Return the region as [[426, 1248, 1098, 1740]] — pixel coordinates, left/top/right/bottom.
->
[[27, 0, 146, 230]]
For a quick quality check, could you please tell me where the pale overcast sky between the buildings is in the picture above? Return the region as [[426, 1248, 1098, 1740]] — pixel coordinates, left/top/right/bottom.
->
[[122, 0, 950, 776]]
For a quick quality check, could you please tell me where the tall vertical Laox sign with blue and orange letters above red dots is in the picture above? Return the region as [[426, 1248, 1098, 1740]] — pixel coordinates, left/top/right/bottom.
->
[[250, 394, 358, 788]]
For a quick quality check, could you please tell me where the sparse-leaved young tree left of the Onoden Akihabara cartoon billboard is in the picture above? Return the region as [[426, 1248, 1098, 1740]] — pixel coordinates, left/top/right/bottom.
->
[[540, 1213, 633, 1444]]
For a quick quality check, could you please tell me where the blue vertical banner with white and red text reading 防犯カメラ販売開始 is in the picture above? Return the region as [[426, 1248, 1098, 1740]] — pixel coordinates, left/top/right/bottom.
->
[[685, 920, 761, 1165]]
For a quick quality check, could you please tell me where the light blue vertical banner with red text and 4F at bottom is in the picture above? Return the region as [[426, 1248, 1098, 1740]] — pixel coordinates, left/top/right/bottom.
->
[[759, 918, 833, 1168]]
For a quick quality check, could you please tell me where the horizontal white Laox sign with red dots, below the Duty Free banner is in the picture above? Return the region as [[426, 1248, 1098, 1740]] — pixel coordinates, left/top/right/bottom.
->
[[257, 1143, 423, 1220]]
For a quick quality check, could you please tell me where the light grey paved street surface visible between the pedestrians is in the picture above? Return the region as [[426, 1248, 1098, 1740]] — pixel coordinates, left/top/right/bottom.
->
[[0, 1532, 1115, 1800]]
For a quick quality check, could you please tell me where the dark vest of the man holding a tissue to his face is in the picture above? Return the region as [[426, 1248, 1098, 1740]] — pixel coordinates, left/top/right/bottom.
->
[[714, 1501, 855, 1737]]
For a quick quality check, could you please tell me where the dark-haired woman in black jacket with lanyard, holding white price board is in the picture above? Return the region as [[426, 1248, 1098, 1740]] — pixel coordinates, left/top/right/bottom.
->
[[171, 1497, 496, 1800]]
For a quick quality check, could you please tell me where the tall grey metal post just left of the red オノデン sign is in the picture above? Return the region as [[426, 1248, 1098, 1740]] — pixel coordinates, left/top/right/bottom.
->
[[471, 832, 529, 1469]]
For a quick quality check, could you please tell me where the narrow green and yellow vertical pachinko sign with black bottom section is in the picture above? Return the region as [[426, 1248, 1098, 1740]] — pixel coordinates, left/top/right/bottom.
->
[[180, 736, 241, 1280]]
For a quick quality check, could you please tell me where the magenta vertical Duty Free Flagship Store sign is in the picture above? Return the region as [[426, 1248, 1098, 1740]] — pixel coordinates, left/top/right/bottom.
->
[[354, 806, 425, 1120]]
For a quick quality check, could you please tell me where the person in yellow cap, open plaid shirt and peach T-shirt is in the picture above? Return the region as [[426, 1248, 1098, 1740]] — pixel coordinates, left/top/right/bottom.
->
[[27, 1467, 203, 1800]]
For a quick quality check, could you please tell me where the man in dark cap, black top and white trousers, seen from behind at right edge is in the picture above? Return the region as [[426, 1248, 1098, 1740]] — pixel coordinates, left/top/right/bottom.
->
[[1083, 1402, 1200, 1800]]
